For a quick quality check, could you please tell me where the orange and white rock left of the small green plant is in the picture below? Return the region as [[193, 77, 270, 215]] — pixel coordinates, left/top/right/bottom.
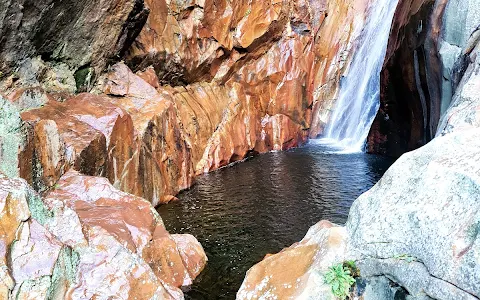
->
[[237, 221, 346, 299]]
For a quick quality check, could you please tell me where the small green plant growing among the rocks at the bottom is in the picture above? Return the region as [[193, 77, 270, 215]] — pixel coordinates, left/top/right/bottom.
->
[[324, 263, 355, 300]]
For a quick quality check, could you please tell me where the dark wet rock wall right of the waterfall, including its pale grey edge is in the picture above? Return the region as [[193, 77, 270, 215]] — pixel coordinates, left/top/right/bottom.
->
[[368, 0, 480, 156]]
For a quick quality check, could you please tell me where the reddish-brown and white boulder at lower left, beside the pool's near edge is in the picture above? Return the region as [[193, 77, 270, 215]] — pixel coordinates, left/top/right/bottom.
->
[[44, 172, 206, 299]]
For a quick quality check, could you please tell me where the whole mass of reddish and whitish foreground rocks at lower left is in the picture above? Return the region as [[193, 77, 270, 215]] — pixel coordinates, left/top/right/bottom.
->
[[0, 171, 207, 299]]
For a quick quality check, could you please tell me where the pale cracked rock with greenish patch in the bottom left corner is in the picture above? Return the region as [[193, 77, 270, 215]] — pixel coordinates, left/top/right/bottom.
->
[[0, 173, 59, 299]]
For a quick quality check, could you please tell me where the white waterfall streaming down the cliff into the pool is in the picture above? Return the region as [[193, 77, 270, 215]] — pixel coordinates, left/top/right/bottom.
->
[[325, 0, 398, 152]]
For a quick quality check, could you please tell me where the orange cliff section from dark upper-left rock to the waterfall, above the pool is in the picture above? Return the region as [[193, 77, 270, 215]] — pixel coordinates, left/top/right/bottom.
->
[[127, 1, 368, 174]]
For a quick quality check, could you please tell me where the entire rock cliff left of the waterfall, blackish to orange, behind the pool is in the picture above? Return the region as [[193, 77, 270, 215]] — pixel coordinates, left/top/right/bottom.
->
[[0, 0, 369, 205]]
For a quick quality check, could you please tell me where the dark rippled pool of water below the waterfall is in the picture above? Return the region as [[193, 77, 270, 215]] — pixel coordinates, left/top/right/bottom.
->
[[158, 144, 393, 300]]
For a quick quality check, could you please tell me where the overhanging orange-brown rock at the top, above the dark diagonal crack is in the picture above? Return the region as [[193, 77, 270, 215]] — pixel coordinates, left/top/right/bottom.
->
[[128, 0, 291, 85]]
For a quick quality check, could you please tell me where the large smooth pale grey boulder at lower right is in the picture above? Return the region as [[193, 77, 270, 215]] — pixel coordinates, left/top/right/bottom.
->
[[346, 129, 480, 299]]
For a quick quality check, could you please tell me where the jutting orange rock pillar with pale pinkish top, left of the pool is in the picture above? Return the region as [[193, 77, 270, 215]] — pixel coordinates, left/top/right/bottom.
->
[[105, 64, 193, 205]]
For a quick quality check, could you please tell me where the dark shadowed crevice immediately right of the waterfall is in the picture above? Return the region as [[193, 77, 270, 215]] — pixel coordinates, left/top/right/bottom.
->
[[367, 0, 444, 157]]
